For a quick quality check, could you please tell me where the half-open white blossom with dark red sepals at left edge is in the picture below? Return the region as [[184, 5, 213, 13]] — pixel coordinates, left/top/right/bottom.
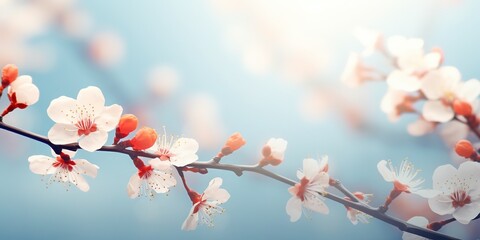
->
[[2, 75, 40, 116]]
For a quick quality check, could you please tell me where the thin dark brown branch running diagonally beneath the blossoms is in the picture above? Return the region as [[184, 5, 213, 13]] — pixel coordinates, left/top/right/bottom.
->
[[0, 122, 456, 240]]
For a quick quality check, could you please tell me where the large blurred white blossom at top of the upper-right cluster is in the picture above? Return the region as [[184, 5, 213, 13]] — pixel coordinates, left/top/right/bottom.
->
[[387, 36, 442, 92]]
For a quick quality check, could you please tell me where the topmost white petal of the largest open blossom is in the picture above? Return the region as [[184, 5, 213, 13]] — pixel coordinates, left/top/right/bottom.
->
[[77, 86, 105, 118]]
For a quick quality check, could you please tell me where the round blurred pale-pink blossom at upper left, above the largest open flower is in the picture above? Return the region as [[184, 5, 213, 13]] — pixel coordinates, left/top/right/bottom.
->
[[88, 32, 125, 67]]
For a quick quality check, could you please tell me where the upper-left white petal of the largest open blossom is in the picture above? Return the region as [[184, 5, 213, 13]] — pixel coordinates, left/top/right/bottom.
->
[[47, 96, 77, 124]]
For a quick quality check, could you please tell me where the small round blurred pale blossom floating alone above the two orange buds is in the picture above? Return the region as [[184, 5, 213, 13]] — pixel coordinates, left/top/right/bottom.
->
[[147, 66, 180, 98]]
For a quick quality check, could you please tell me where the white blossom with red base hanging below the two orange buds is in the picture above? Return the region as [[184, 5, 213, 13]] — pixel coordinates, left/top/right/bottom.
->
[[127, 159, 177, 199]]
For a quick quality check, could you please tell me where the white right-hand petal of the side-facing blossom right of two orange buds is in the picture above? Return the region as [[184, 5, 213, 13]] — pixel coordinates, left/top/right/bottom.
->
[[170, 138, 198, 167]]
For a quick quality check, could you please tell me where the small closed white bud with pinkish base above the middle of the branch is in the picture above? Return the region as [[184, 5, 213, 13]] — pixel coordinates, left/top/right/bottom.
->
[[259, 138, 287, 166]]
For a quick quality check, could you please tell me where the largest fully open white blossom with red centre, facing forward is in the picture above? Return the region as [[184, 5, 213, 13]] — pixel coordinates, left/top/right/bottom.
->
[[47, 86, 123, 152]]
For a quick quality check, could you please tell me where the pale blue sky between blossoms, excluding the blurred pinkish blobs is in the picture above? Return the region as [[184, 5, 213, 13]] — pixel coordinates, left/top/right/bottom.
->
[[0, 0, 480, 239]]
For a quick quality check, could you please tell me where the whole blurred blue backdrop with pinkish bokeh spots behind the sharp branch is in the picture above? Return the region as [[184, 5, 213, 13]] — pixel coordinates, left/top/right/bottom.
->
[[0, 0, 480, 239]]
